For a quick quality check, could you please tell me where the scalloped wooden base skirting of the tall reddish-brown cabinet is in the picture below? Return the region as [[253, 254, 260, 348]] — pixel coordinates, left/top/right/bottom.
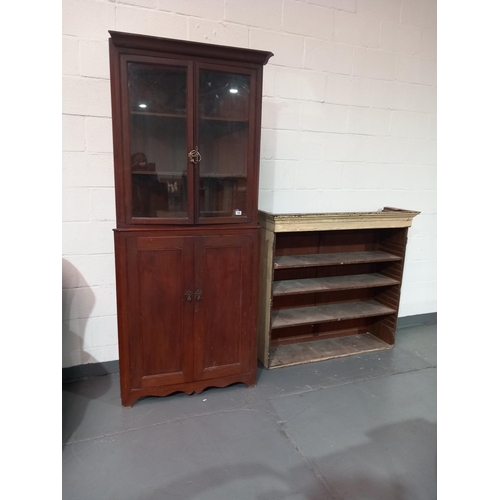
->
[[122, 373, 255, 408]]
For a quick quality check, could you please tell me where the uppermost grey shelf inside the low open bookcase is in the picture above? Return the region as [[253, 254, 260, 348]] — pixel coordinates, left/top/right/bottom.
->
[[274, 251, 401, 269]]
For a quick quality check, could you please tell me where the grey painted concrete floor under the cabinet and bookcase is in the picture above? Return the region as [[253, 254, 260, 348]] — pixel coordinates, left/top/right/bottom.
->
[[62, 324, 437, 500]]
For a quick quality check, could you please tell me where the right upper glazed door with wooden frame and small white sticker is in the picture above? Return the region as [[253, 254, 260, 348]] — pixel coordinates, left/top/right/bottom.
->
[[195, 64, 258, 224]]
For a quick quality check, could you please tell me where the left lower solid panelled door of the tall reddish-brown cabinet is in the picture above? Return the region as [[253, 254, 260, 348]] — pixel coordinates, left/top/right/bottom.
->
[[127, 236, 194, 389]]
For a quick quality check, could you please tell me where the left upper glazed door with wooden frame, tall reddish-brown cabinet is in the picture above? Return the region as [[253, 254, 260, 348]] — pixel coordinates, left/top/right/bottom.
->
[[117, 56, 194, 224]]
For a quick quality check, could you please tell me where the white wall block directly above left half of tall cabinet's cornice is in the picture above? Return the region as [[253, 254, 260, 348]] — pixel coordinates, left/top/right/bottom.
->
[[116, 6, 188, 40]]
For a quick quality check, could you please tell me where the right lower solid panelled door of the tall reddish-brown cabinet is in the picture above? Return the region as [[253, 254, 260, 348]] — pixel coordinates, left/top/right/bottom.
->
[[190, 234, 256, 380]]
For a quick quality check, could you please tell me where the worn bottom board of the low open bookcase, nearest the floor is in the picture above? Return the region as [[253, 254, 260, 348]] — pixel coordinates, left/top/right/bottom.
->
[[267, 333, 393, 370]]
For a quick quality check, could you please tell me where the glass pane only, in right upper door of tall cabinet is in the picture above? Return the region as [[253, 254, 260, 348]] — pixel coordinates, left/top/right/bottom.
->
[[198, 70, 250, 219]]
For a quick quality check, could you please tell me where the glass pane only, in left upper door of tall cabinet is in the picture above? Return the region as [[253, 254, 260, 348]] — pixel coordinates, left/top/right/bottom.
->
[[128, 63, 187, 218]]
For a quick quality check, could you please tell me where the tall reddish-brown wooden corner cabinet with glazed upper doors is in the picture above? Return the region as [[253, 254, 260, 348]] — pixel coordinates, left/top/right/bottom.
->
[[109, 31, 272, 407]]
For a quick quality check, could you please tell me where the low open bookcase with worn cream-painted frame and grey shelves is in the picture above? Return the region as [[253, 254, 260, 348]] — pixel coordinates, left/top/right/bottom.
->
[[258, 208, 419, 369]]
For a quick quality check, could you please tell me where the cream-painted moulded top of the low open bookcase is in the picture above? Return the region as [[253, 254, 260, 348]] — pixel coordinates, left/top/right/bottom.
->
[[259, 207, 420, 233]]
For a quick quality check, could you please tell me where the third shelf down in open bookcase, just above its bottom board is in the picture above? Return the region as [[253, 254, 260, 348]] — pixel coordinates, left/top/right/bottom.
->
[[271, 300, 396, 330]]
